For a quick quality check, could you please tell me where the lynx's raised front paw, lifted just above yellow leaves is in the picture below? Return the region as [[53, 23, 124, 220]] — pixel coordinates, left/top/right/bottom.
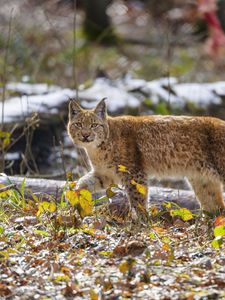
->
[[76, 172, 112, 192]]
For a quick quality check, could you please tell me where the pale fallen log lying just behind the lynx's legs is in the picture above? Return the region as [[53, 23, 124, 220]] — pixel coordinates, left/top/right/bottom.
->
[[0, 175, 225, 210]]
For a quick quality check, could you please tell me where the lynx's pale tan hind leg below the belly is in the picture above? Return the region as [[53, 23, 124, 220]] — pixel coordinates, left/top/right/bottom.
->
[[188, 178, 225, 212]]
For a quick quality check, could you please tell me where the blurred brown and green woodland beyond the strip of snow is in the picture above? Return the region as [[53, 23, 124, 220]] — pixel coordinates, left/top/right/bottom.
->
[[0, 0, 225, 87]]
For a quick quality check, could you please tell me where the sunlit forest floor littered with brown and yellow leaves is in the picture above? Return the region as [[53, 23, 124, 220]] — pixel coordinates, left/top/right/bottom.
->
[[0, 182, 225, 300]]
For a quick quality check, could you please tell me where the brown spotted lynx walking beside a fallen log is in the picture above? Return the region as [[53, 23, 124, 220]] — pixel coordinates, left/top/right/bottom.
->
[[68, 99, 225, 216]]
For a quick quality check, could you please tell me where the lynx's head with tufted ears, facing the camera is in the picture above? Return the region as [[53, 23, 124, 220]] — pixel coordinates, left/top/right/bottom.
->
[[68, 98, 109, 147]]
